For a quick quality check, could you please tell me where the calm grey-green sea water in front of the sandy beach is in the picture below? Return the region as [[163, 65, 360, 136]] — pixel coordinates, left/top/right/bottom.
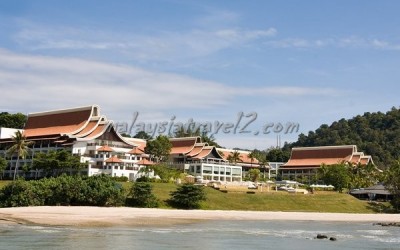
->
[[0, 220, 400, 250]]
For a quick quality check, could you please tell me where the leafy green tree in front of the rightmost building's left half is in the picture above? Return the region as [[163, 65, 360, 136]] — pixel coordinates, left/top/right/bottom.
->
[[319, 163, 350, 193]]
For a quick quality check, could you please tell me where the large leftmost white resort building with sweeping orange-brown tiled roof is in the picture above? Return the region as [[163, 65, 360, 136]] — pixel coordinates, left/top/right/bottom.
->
[[0, 105, 153, 180]]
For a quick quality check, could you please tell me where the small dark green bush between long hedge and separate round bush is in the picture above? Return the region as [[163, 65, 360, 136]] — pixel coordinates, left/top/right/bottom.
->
[[131, 182, 158, 208]]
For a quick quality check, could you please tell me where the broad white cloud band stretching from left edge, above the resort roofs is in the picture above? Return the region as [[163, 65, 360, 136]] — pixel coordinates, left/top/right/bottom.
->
[[0, 50, 334, 119]]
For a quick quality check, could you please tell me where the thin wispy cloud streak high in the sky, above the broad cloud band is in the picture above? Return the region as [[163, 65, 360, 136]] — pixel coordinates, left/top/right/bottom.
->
[[14, 21, 277, 61]]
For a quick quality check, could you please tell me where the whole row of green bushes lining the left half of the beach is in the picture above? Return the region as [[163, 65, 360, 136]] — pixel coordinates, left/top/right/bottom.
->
[[0, 174, 206, 209]]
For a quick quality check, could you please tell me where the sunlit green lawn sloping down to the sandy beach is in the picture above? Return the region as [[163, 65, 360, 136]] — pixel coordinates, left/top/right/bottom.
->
[[0, 181, 384, 213]]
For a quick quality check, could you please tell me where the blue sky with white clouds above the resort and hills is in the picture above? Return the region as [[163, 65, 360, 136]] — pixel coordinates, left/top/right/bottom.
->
[[0, 0, 400, 149]]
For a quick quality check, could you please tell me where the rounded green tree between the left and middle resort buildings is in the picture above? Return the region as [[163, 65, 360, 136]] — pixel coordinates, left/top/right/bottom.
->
[[144, 135, 172, 162]]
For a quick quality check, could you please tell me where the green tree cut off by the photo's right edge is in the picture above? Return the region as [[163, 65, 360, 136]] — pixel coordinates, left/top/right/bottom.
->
[[385, 161, 400, 211]]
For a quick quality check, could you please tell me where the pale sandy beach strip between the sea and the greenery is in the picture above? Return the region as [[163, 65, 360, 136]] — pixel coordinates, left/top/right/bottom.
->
[[0, 206, 400, 226]]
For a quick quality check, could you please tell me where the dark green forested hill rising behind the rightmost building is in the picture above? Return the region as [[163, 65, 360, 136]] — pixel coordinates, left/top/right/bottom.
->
[[284, 107, 400, 168]]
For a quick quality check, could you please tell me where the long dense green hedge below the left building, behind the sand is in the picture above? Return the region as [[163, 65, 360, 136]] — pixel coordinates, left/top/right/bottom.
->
[[0, 175, 125, 207]]
